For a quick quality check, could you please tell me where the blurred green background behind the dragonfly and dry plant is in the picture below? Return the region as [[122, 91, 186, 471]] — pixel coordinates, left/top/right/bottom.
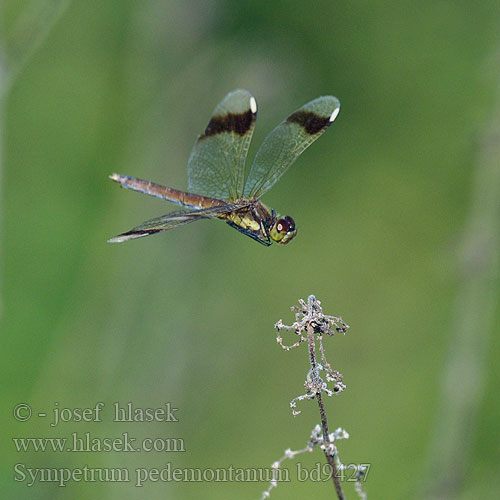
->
[[0, 0, 500, 499]]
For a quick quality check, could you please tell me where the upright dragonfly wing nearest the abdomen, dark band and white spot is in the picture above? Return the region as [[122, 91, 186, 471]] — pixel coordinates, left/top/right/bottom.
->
[[188, 89, 257, 200]]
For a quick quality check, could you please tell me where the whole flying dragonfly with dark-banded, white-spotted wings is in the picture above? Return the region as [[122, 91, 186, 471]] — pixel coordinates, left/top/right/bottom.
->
[[108, 89, 340, 246]]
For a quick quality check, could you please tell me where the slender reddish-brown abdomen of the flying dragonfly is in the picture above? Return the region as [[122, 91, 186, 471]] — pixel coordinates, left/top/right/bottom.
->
[[109, 174, 226, 208]]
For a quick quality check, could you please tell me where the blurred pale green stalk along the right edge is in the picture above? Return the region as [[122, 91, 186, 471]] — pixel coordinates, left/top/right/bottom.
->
[[426, 80, 500, 499]]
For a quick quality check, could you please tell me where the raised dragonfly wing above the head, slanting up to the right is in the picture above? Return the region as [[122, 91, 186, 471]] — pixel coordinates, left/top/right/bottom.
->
[[243, 96, 340, 198]]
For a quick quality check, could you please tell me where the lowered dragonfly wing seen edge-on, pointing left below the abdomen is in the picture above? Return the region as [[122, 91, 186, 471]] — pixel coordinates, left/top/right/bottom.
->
[[108, 203, 244, 243]]
